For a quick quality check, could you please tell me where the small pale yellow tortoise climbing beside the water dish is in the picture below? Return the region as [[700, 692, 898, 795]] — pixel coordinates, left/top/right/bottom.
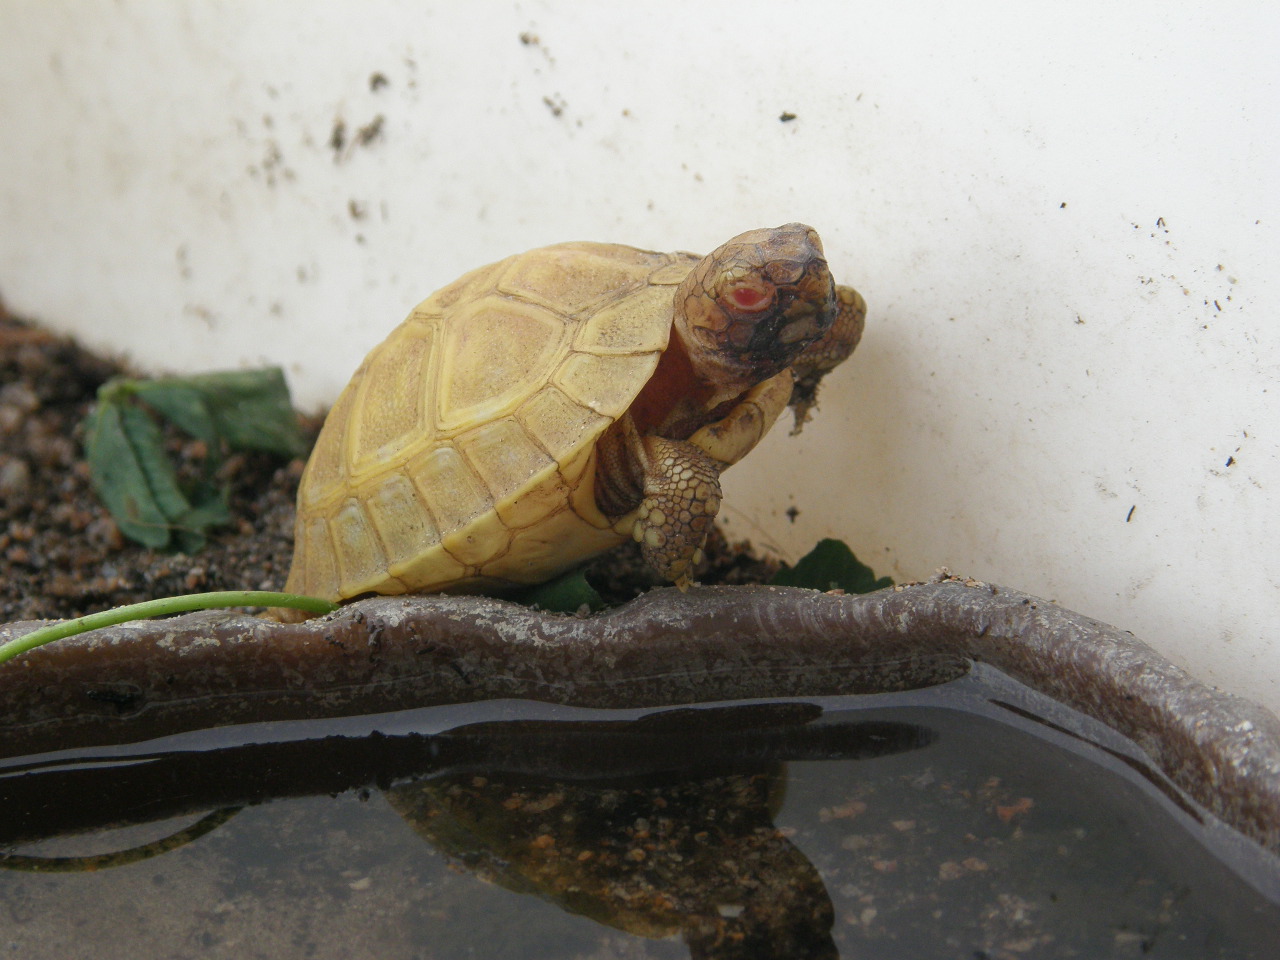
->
[[285, 224, 865, 616]]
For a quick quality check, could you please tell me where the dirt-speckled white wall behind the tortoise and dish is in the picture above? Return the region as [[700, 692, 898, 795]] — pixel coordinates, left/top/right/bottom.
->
[[0, 0, 1280, 709]]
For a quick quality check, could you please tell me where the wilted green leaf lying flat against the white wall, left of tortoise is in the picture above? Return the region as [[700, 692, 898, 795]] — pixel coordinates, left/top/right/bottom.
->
[[137, 367, 307, 457]]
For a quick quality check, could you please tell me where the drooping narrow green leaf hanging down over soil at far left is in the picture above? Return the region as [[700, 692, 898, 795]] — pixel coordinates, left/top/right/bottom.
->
[[84, 402, 169, 548]]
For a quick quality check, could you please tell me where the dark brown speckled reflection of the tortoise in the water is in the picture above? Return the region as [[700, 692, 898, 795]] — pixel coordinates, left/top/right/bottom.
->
[[387, 714, 932, 957]]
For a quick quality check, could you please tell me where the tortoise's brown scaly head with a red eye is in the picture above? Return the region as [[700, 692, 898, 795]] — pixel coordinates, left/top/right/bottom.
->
[[675, 223, 836, 398]]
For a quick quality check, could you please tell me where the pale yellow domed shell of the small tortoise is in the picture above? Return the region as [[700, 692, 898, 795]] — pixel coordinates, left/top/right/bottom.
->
[[287, 243, 737, 599]]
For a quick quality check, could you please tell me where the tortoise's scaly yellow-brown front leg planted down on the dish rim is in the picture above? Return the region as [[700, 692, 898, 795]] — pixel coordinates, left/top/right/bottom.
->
[[631, 436, 724, 590]]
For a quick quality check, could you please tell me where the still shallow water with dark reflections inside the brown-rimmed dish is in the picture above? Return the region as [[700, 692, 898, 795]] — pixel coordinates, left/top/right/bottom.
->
[[0, 667, 1280, 960]]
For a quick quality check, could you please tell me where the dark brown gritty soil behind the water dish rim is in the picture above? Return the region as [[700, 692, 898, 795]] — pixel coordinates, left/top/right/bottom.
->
[[0, 306, 777, 622]]
